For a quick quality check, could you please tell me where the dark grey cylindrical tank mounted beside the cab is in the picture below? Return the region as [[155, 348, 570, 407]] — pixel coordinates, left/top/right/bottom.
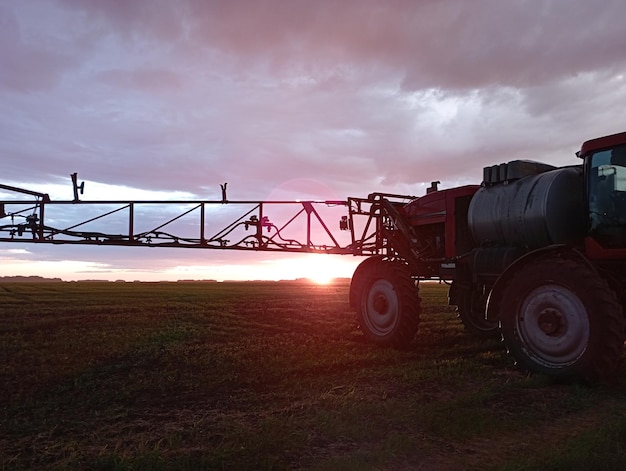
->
[[468, 167, 586, 249]]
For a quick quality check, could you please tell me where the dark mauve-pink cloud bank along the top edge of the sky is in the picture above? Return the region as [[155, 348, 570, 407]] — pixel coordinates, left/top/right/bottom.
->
[[65, 0, 626, 89]]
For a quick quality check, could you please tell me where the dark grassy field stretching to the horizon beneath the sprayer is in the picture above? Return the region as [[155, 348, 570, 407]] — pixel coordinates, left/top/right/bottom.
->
[[0, 282, 626, 471]]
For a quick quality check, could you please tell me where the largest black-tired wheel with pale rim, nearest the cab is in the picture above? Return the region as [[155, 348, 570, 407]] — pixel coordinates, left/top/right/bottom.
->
[[500, 257, 624, 382]]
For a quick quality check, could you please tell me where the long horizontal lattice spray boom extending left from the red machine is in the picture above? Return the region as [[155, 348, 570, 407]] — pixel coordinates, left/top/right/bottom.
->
[[0, 182, 415, 256]]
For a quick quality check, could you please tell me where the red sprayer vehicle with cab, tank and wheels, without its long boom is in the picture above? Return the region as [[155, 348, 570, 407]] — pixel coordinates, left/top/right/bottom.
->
[[350, 133, 626, 381]]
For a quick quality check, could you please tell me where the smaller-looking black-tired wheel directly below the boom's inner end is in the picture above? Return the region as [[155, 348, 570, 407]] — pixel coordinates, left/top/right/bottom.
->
[[355, 258, 420, 348]]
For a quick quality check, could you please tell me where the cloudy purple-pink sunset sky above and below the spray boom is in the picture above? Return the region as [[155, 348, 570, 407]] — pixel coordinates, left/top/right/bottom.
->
[[0, 0, 626, 281]]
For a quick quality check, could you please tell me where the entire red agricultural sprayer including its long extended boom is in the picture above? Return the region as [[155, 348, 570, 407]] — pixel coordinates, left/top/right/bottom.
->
[[0, 133, 626, 381]]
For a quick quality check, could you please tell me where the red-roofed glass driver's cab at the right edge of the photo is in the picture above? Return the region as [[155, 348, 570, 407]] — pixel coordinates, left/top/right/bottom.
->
[[579, 133, 626, 249]]
